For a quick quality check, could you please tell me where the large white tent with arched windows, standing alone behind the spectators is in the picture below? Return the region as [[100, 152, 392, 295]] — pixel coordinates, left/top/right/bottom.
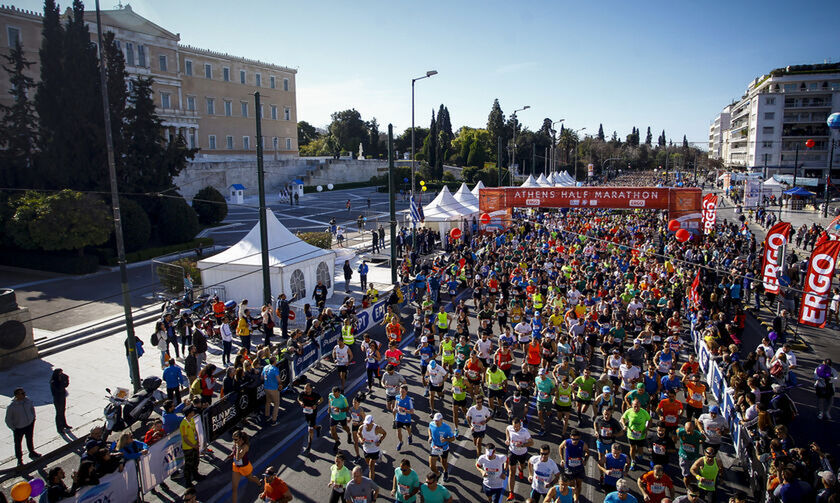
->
[[198, 211, 335, 306]]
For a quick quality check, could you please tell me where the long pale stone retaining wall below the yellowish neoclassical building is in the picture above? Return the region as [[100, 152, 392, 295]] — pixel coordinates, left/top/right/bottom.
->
[[175, 158, 388, 201]]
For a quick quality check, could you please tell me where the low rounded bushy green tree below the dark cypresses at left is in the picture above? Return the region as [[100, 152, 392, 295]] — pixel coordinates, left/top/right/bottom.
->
[[10, 189, 113, 255]]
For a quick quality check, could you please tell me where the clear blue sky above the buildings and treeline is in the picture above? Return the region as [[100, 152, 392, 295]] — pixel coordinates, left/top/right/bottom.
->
[[15, 0, 840, 146]]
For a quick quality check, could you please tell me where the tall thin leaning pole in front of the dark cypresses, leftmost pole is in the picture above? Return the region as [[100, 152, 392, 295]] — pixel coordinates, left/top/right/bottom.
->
[[96, 0, 140, 392]]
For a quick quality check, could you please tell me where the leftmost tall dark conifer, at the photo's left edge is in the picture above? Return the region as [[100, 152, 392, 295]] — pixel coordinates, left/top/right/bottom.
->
[[0, 40, 37, 188]]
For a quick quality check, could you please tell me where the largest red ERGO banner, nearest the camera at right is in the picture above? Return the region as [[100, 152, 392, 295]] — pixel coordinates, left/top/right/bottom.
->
[[799, 241, 840, 328]]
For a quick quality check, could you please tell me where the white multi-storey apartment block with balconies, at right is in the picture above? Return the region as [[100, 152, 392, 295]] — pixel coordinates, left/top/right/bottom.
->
[[709, 63, 840, 180]]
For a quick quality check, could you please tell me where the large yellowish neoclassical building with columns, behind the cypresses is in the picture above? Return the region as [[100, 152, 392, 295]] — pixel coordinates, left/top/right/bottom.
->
[[0, 5, 298, 159]]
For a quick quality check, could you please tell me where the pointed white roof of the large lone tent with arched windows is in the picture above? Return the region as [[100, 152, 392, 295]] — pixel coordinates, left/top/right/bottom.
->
[[200, 211, 335, 267]]
